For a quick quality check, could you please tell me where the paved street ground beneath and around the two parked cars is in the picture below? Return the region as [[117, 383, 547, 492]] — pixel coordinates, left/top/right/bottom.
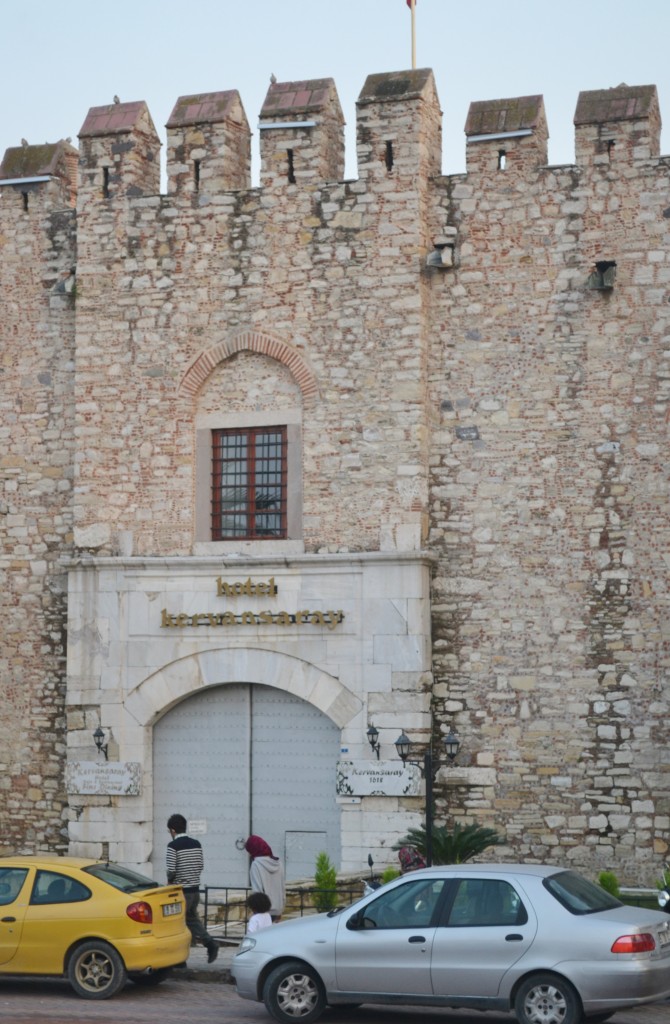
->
[[0, 948, 670, 1024]]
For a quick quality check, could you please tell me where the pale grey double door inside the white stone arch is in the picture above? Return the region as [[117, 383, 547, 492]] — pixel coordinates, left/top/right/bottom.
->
[[153, 683, 340, 886]]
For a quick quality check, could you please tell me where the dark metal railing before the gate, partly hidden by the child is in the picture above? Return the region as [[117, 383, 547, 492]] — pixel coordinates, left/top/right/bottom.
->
[[200, 883, 363, 943]]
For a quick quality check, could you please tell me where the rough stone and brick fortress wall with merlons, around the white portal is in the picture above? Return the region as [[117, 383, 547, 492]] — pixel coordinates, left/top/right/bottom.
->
[[0, 70, 670, 883]]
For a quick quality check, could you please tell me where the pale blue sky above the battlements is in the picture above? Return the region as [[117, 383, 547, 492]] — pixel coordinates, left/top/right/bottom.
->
[[0, 0, 670, 183]]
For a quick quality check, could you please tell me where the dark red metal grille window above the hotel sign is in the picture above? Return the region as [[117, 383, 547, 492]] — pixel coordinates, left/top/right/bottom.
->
[[212, 427, 287, 541]]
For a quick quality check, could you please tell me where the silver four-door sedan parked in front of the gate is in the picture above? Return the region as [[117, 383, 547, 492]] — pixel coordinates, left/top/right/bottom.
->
[[233, 864, 670, 1024]]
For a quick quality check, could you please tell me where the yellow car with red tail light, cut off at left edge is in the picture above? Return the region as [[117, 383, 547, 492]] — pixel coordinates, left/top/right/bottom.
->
[[0, 856, 191, 999]]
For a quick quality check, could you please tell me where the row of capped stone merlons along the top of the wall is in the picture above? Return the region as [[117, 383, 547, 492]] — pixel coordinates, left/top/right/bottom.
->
[[0, 76, 661, 214]]
